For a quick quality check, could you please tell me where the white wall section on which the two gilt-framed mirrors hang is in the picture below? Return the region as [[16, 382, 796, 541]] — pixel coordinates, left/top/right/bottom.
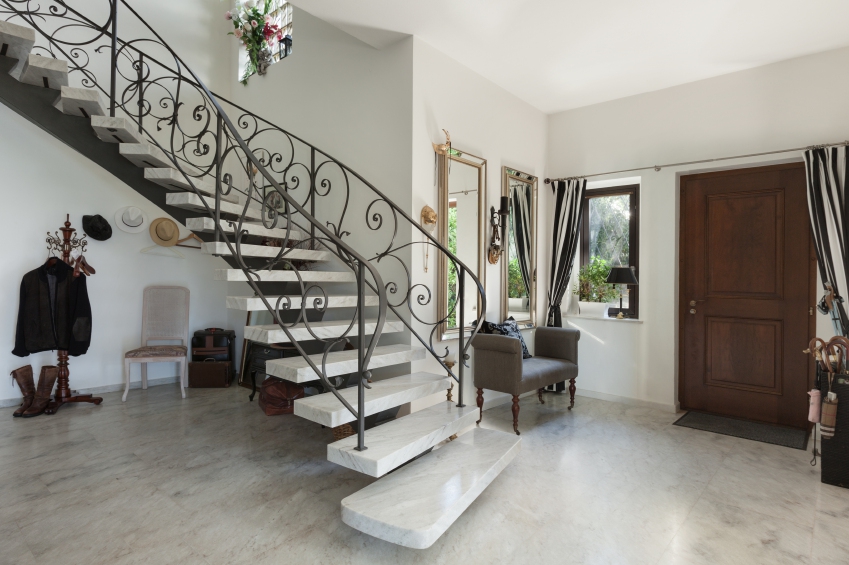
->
[[411, 37, 550, 406]]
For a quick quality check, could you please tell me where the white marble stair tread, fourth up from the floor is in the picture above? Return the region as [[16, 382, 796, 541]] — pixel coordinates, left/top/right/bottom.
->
[[265, 345, 426, 383]]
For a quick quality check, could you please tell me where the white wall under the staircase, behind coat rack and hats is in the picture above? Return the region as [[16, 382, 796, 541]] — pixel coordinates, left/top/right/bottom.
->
[[0, 105, 244, 405]]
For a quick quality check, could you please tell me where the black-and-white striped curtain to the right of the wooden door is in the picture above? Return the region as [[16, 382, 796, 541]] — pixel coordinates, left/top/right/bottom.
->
[[805, 146, 849, 336]]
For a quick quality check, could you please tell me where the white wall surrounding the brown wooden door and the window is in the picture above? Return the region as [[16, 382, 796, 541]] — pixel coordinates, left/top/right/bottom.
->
[[540, 45, 849, 409]]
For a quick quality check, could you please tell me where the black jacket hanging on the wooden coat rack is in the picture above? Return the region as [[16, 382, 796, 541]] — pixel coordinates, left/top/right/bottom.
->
[[12, 260, 91, 357]]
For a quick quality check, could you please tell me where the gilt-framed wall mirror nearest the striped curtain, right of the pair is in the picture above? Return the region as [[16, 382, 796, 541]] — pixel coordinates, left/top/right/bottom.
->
[[501, 167, 537, 328]]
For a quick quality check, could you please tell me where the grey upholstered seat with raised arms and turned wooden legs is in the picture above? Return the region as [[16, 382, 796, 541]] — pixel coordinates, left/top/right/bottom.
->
[[472, 328, 581, 435]]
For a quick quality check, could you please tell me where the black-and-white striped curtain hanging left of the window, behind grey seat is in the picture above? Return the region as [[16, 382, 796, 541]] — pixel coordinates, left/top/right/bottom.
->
[[546, 179, 587, 328]]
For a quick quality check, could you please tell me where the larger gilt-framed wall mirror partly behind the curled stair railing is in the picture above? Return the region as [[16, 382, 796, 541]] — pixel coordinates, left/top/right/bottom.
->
[[434, 145, 486, 340]]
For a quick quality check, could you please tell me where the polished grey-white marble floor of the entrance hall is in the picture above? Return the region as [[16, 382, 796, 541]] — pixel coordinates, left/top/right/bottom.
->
[[0, 386, 849, 565]]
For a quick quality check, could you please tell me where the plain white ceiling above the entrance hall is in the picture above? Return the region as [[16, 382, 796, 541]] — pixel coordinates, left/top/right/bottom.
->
[[294, 0, 849, 113]]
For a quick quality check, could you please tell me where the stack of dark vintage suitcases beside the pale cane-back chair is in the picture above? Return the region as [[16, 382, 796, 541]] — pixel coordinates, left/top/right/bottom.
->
[[189, 328, 236, 388]]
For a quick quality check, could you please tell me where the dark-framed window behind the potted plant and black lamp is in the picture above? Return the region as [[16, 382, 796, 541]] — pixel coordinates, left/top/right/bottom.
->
[[581, 185, 640, 318]]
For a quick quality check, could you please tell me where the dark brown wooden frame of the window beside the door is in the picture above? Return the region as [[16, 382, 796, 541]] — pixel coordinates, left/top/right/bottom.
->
[[580, 184, 640, 320]]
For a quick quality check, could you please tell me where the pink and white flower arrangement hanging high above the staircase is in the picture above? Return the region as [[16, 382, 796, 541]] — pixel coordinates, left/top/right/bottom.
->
[[224, 0, 283, 85]]
